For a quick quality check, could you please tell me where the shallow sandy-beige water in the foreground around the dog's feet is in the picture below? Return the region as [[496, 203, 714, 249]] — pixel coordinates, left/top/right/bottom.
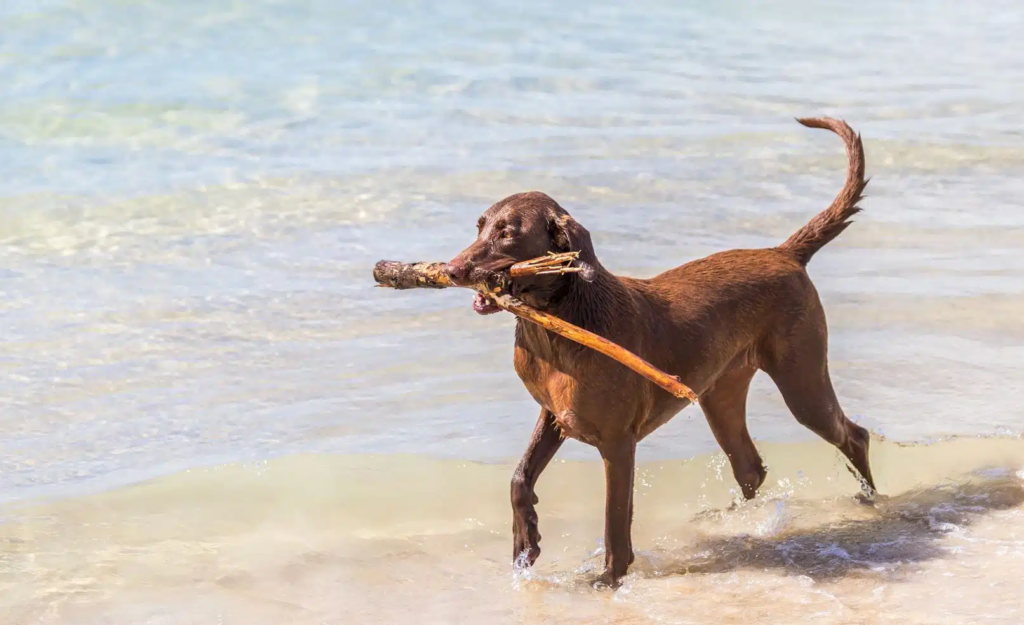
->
[[6, 439, 1024, 623]]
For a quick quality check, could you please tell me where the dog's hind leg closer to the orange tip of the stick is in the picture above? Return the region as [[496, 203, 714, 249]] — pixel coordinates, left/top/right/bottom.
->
[[700, 366, 767, 499]]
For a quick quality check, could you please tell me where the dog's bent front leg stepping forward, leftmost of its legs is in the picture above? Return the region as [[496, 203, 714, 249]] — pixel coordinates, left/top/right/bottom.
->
[[512, 408, 564, 566]]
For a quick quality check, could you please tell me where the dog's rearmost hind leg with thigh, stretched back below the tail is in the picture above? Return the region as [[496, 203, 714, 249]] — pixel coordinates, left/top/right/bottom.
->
[[763, 311, 876, 496]]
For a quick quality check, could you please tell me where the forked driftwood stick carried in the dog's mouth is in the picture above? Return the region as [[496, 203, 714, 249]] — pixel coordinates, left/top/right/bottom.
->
[[374, 252, 697, 404]]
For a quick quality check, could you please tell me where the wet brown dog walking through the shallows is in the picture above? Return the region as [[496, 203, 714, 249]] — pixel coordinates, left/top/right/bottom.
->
[[447, 118, 874, 585]]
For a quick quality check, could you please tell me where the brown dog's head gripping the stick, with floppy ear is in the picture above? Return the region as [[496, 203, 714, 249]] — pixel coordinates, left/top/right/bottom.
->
[[446, 192, 597, 315]]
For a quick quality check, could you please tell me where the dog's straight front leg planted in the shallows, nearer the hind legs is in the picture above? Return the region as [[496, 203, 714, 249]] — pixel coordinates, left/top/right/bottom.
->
[[597, 439, 636, 588]]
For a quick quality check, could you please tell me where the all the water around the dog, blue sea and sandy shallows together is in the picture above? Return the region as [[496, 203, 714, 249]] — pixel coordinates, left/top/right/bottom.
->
[[0, 0, 1024, 624]]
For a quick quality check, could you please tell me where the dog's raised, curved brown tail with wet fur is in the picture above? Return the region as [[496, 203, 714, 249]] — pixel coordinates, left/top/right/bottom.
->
[[778, 117, 867, 266]]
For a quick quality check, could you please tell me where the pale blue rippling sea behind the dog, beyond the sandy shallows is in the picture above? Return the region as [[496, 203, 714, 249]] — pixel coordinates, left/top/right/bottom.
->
[[0, 0, 1024, 500]]
